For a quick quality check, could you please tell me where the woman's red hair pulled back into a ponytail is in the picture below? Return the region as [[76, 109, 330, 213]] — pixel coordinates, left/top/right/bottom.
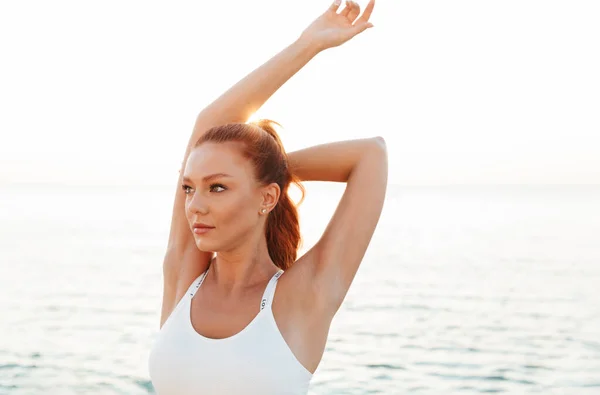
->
[[194, 119, 306, 270]]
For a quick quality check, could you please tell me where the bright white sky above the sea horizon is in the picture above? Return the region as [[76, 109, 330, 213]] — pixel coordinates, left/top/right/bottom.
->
[[0, 0, 600, 185]]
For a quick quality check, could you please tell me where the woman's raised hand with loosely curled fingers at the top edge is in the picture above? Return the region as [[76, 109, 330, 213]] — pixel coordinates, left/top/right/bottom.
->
[[301, 0, 375, 51]]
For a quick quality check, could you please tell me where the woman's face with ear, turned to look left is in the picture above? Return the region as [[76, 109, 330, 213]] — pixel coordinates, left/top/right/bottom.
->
[[183, 142, 278, 252]]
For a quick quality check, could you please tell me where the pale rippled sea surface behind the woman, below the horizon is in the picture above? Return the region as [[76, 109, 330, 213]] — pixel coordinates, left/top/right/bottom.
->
[[0, 183, 600, 395]]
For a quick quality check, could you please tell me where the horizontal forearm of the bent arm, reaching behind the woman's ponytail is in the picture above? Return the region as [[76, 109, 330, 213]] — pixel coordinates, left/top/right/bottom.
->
[[288, 137, 379, 182]]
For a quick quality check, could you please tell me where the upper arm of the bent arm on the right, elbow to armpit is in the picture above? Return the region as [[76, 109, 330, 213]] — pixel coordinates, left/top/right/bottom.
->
[[305, 137, 388, 314]]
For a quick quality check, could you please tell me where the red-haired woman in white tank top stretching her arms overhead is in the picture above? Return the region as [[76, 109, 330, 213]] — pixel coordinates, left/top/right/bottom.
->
[[149, 0, 387, 395]]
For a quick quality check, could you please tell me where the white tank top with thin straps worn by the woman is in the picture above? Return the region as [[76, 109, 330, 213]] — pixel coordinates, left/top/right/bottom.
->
[[148, 269, 312, 395]]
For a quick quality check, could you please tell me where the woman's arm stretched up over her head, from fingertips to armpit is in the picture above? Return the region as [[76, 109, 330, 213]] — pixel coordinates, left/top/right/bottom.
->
[[161, 0, 374, 326]]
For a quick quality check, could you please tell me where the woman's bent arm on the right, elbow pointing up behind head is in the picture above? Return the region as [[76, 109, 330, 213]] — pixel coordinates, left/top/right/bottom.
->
[[288, 137, 388, 317]]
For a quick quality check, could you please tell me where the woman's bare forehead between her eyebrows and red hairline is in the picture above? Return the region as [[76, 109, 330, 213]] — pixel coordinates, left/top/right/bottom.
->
[[183, 141, 252, 182]]
